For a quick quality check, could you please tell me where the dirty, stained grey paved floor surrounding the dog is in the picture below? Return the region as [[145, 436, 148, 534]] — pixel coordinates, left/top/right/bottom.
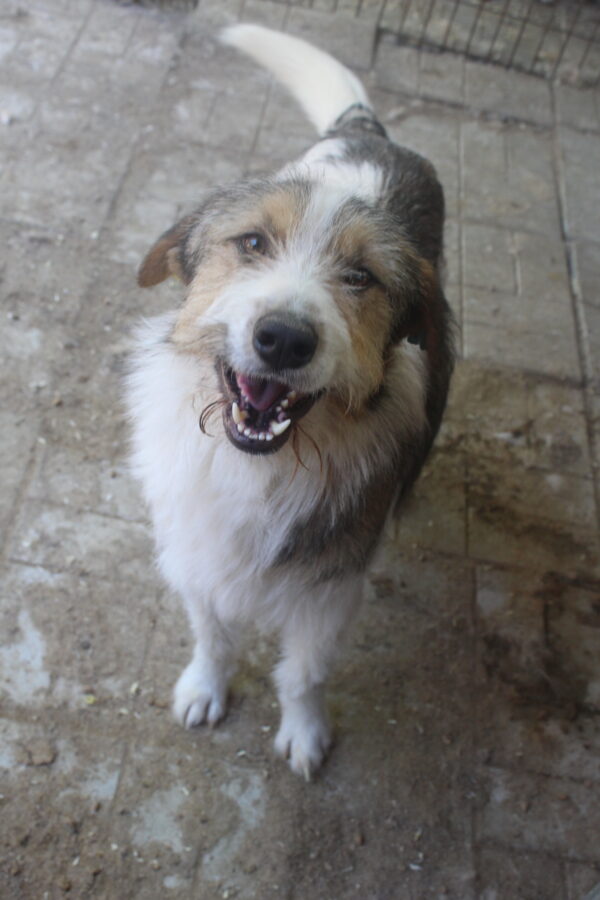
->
[[0, 0, 600, 900]]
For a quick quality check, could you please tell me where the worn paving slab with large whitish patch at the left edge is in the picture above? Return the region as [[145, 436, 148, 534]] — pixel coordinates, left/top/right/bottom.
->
[[0, 565, 156, 719]]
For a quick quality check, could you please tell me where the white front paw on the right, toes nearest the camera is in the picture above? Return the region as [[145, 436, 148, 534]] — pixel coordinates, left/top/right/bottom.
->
[[275, 701, 331, 781]]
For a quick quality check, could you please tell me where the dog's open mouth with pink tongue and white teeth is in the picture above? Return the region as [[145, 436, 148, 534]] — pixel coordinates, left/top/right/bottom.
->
[[221, 364, 318, 453]]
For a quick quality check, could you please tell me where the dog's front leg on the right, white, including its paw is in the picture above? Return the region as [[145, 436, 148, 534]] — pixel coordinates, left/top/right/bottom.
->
[[275, 575, 362, 781]]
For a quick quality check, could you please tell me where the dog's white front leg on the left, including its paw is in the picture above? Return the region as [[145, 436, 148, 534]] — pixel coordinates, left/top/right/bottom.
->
[[173, 598, 237, 728]]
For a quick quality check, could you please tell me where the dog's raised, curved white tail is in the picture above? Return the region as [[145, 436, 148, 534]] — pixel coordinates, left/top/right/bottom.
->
[[221, 25, 371, 135]]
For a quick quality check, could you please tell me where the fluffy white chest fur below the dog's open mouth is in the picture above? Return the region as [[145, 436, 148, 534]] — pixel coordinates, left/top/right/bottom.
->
[[128, 315, 342, 628]]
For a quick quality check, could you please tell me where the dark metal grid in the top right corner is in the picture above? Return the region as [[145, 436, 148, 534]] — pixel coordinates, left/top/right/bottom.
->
[[376, 0, 600, 84]]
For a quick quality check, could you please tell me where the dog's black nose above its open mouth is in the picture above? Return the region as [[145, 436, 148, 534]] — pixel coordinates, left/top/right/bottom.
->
[[253, 313, 318, 370]]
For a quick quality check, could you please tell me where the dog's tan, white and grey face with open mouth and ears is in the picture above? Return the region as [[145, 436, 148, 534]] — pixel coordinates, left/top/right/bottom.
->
[[139, 178, 433, 454]]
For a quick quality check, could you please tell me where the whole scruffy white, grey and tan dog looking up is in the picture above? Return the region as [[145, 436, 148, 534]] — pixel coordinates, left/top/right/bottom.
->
[[128, 25, 453, 778]]
